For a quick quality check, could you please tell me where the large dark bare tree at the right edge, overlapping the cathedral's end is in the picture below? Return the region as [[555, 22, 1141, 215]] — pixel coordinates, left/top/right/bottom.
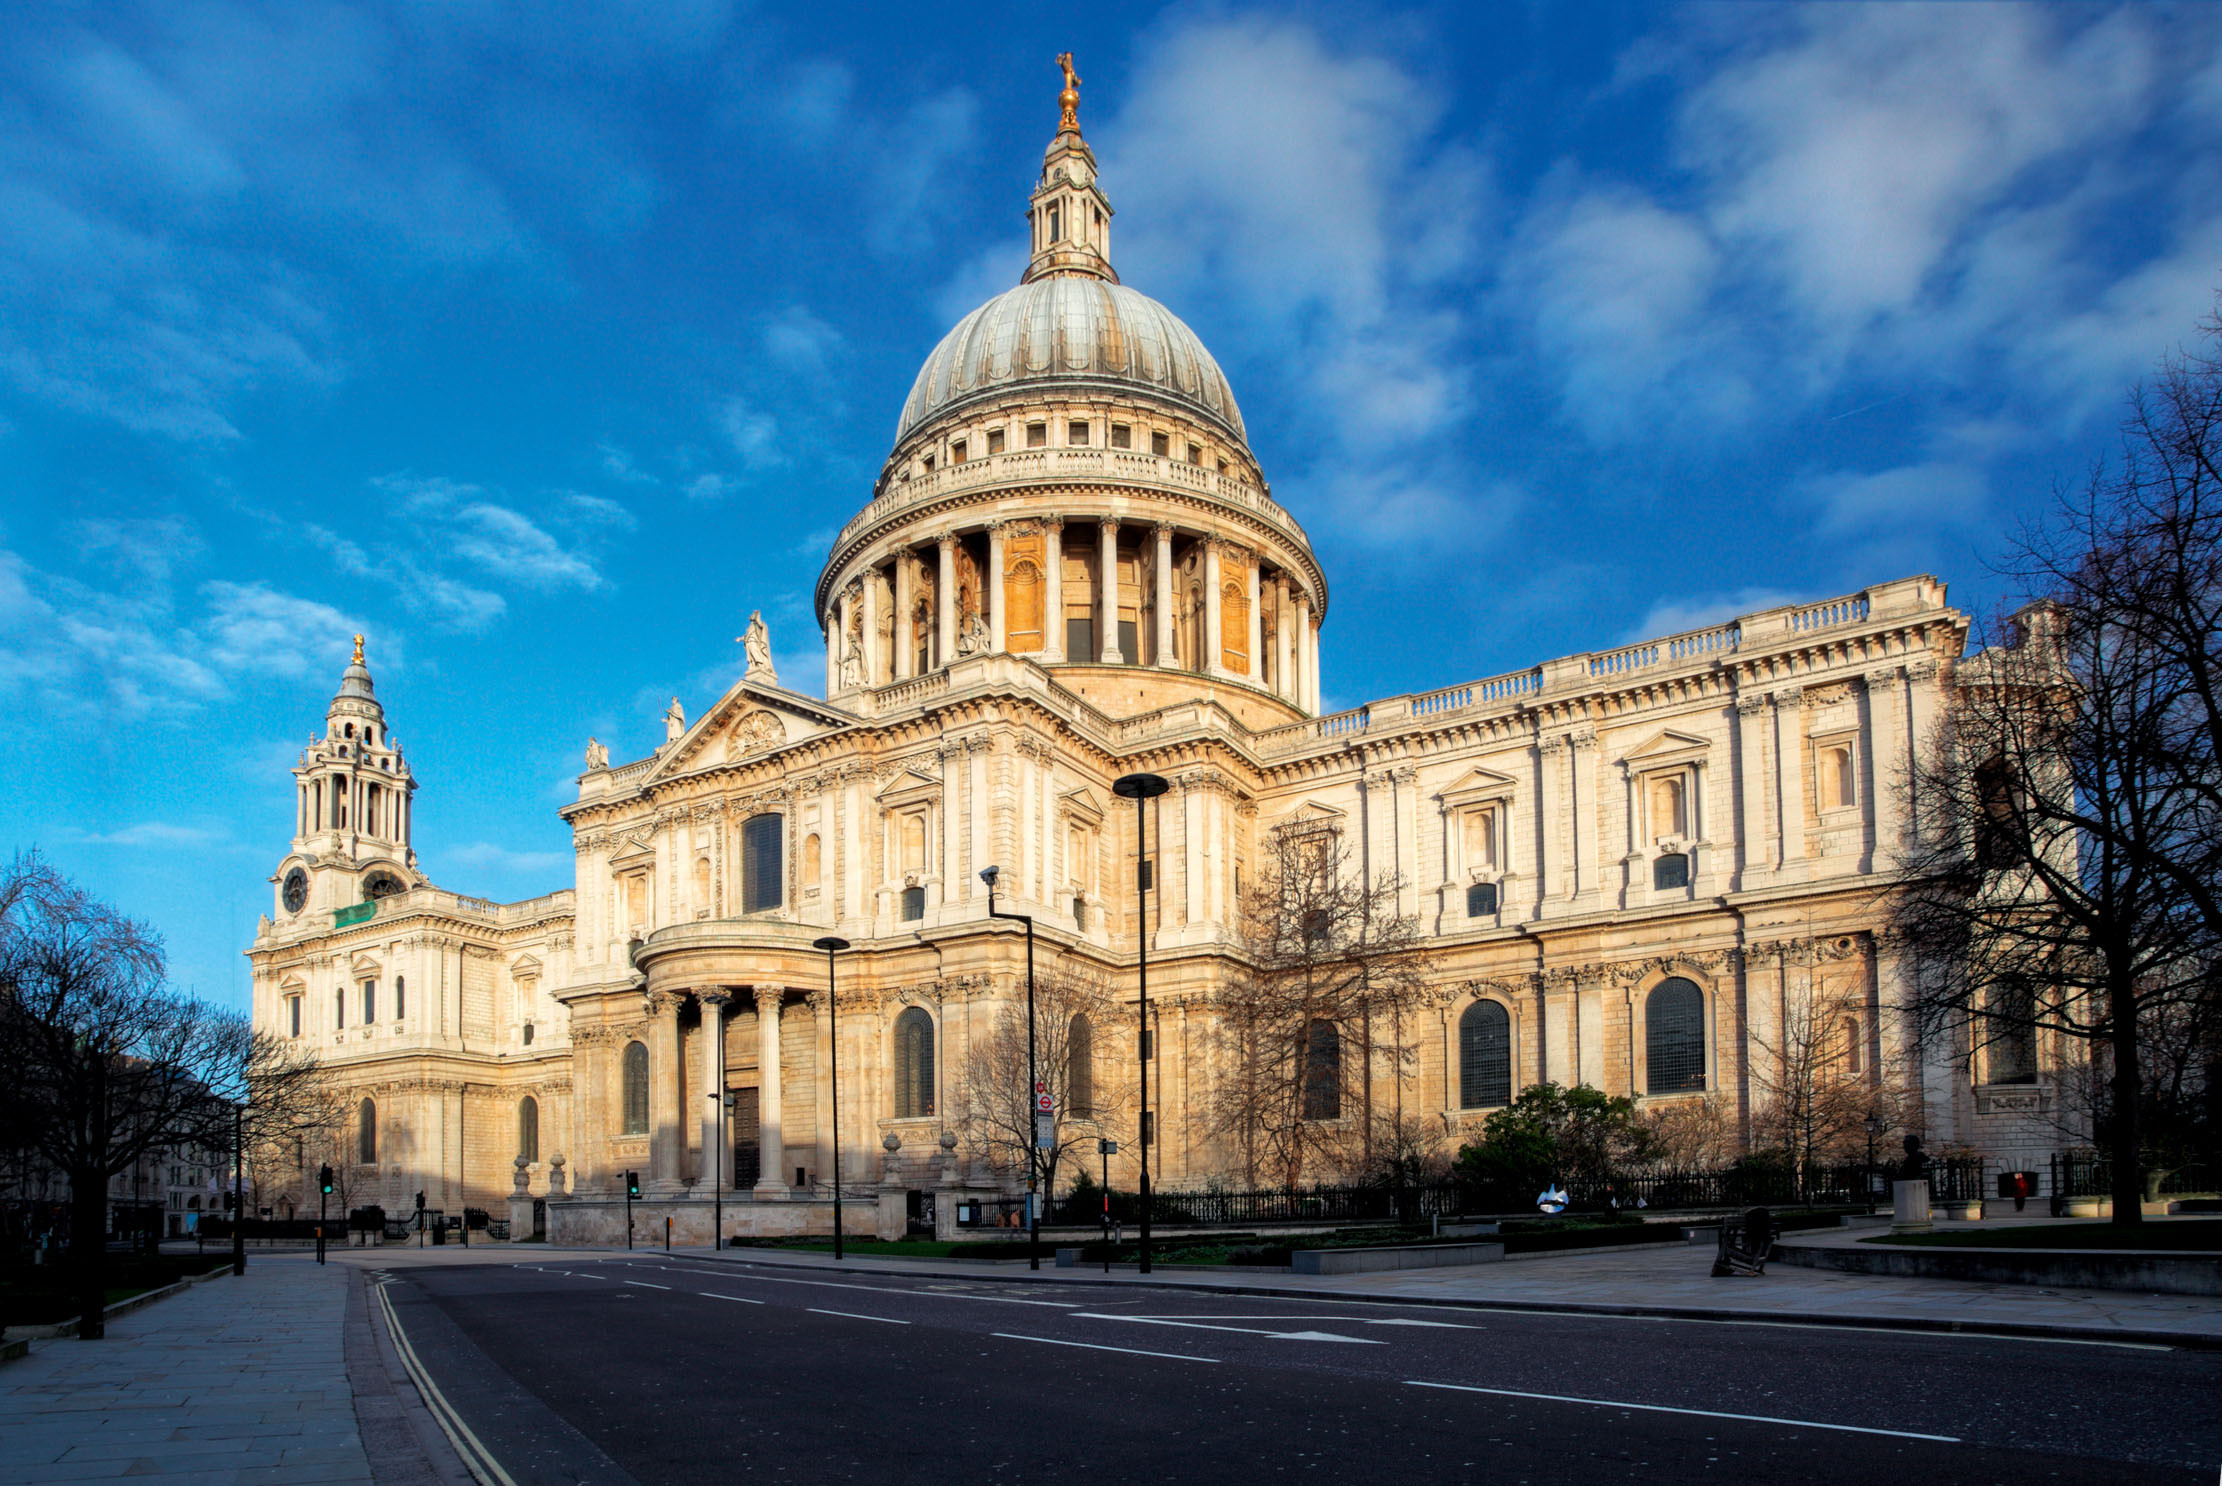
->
[[1898, 304, 2222, 1222]]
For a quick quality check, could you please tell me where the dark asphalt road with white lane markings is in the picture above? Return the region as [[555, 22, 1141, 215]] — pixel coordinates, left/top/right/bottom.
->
[[380, 1255, 2222, 1486]]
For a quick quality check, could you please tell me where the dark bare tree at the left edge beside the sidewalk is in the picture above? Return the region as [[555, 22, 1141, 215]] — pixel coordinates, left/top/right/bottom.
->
[[0, 853, 324, 1339]]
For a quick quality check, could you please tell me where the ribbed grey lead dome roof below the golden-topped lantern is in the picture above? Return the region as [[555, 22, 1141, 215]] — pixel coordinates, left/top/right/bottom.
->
[[895, 273, 1249, 444]]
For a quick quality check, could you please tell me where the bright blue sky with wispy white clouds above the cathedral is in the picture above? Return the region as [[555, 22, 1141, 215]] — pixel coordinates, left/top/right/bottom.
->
[[0, 0, 2222, 1002]]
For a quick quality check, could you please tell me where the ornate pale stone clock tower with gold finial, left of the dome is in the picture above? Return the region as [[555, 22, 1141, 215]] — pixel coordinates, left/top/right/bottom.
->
[[273, 635, 424, 924]]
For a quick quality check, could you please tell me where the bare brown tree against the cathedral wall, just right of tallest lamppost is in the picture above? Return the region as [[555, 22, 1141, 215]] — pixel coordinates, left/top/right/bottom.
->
[[1209, 826, 1424, 1186]]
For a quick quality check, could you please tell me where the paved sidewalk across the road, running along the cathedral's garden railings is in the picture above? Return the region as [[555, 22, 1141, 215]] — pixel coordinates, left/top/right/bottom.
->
[[639, 1228, 2222, 1348]]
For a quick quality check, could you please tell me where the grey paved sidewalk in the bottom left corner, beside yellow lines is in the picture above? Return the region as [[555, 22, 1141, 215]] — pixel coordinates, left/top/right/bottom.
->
[[0, 1257, 399, 1486]]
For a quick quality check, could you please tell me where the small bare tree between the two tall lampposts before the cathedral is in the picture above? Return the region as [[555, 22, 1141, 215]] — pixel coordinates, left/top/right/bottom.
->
[[958, 968, 1131, 1199]]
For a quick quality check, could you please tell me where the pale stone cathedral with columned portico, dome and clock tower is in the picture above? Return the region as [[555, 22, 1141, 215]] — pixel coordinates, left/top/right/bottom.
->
[[249, 75, 2060, 1242]]
